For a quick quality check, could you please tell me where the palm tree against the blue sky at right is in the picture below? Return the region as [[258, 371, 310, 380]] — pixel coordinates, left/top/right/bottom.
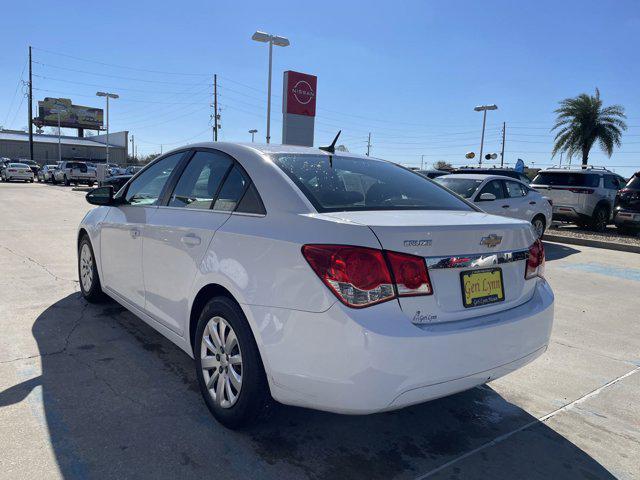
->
[[551, 88, 627, 168]]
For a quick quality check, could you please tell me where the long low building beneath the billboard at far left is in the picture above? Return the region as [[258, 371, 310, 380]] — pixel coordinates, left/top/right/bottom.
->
[[0, 130, 129, 165]]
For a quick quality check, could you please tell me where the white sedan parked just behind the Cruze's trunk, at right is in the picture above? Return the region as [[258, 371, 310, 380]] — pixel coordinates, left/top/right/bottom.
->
[[435, 174, 553, 238]]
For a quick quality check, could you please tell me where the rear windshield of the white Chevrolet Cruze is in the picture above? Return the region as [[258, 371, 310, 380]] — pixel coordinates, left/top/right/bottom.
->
[[273, 154, 473, 212]]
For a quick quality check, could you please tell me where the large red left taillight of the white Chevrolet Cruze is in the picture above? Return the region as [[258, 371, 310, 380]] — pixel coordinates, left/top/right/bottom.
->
[[302, 245, 433, 307]]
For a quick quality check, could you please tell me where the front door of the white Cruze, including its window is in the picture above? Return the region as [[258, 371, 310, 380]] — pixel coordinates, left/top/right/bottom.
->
[[100, 152, 185, 309]]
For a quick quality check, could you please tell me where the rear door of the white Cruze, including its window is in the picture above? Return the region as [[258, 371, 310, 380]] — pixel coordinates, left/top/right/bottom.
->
[[142, 150, 245, 335]]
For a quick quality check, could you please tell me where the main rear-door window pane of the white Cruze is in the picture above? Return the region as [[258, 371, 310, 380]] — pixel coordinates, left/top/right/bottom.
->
[[169, 152, 232, 209]]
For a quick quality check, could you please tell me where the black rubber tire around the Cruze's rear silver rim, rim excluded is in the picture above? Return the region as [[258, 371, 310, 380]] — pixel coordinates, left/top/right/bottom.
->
[[194, 297, 271, 429]]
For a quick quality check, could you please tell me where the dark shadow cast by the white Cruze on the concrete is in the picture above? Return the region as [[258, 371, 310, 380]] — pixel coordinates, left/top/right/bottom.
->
[[0, 294, 614, 480]]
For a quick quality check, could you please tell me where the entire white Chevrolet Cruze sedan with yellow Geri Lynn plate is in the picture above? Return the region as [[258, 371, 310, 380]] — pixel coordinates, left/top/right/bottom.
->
[[77, 143, 554, 428]]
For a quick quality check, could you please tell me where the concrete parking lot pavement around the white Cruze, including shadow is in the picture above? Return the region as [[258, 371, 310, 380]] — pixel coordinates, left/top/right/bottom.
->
[[0, 183, 640, 479]]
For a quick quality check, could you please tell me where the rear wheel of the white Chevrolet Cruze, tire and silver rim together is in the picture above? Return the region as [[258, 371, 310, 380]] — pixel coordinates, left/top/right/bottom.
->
[[194, 297, 271, 429]]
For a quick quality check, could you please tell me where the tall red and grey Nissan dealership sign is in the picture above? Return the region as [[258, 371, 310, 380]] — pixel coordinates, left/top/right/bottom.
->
[[282, 70, 318, 147]]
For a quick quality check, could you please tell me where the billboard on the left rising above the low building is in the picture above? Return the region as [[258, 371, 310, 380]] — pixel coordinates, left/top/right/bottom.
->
[[34, 97, 104, 130]]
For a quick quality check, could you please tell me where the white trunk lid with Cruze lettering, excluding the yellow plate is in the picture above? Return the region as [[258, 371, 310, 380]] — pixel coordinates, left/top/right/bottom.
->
[[323, 210, 535, 324]]
